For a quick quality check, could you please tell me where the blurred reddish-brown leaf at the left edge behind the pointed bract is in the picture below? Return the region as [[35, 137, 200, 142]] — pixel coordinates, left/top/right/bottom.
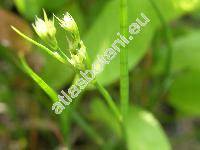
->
[[0, 9, 32, 53]]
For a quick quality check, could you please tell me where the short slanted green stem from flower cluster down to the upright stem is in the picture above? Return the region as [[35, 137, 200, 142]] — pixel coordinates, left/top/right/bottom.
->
[[94, 81, 122, 122]]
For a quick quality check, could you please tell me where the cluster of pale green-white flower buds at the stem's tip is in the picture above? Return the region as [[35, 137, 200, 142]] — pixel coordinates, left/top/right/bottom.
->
[[33, 11, 86, 70]]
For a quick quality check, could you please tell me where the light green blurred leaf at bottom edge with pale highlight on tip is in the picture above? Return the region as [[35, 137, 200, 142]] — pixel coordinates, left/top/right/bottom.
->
[[125, 107, 171, 150]]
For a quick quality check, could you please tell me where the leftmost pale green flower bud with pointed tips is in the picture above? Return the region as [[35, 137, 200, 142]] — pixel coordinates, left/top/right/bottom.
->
[[33, 11, 58, 49]]
